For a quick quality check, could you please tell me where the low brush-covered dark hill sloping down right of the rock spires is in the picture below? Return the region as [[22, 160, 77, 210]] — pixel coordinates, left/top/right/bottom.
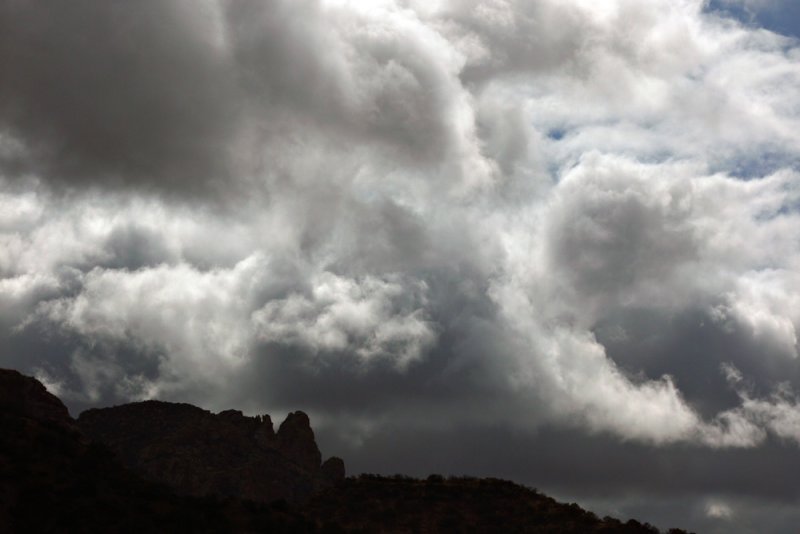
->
[[306, 475, 686, 534]]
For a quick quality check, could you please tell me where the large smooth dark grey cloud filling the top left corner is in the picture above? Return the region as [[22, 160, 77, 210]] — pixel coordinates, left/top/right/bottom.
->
[[0, 2, 237, 198]]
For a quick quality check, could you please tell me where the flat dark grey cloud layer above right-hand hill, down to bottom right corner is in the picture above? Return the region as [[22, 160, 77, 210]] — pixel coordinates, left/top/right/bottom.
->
[[317, 422, 800, 534]]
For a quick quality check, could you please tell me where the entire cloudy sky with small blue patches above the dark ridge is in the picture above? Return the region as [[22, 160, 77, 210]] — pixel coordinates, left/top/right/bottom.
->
[[0, 0, 800, 533]]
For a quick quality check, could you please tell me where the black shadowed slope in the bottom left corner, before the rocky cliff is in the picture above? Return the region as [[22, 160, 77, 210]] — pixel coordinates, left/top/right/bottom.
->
[[0, 369, 328, 534]]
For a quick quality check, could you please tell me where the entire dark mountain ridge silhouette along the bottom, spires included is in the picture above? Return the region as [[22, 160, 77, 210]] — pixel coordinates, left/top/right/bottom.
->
[[0, 370, 682, 534]]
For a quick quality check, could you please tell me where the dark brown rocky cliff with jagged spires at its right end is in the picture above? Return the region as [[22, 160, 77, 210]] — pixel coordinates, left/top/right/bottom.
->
[[77, 401, 344, 502]]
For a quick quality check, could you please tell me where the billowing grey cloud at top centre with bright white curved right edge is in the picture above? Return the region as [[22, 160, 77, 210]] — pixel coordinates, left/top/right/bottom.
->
[[227, 0, 496, 196]]
